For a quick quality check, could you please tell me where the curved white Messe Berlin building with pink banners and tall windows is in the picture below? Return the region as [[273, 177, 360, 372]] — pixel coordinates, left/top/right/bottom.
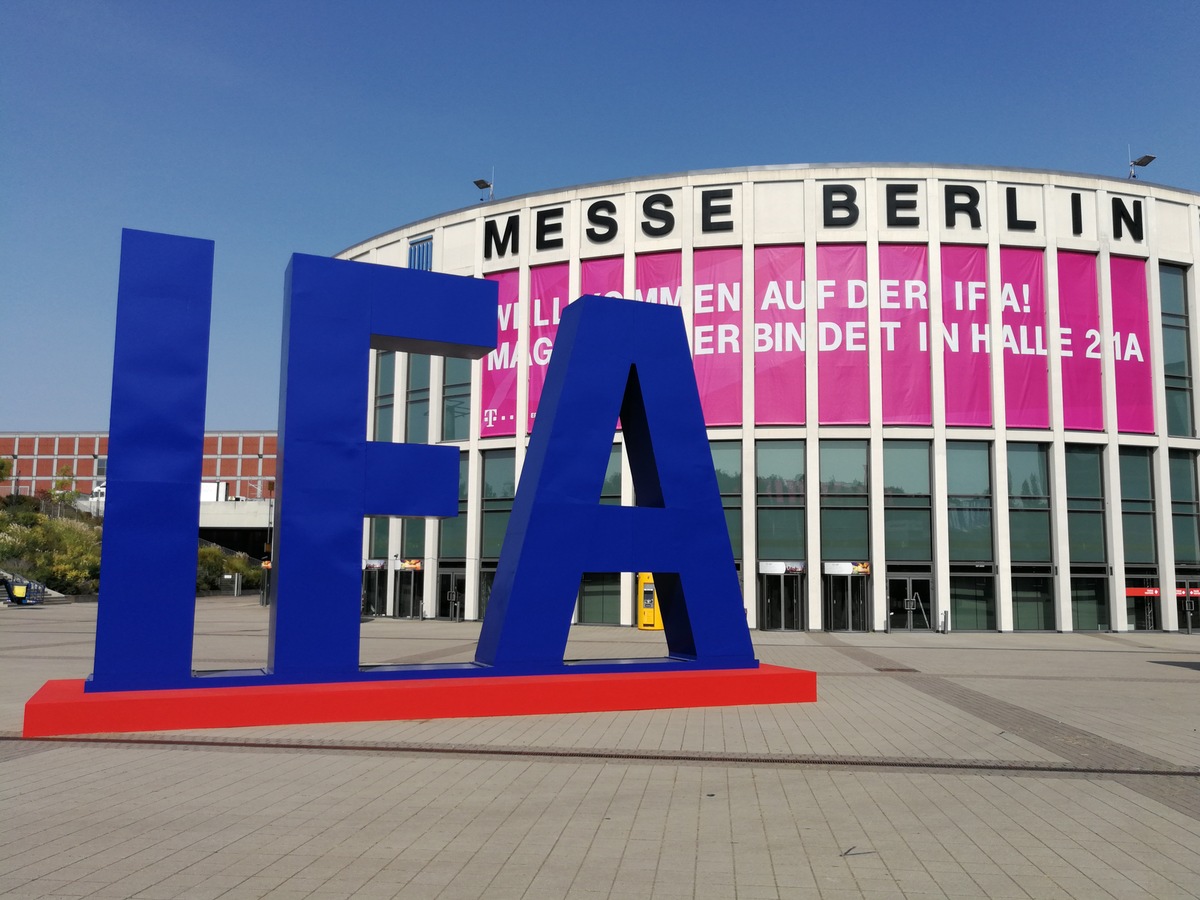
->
[[340, 164, 1200, 631]]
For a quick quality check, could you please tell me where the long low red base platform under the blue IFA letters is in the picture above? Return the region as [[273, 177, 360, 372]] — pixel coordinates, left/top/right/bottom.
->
[[24, 666, 817, 738]]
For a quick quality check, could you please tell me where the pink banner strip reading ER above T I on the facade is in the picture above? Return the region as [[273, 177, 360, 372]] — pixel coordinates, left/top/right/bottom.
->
[[880, 244, 934, 425]]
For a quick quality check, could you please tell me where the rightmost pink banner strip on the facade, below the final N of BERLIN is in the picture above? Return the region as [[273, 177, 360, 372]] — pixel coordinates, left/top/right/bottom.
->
[[1109, 257, 1154, 434]]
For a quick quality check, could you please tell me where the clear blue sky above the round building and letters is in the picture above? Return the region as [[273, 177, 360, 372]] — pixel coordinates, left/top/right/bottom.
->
[[0, 0, 1200, 431]]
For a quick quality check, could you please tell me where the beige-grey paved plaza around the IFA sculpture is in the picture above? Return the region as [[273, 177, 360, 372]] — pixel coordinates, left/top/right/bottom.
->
[[0, 598, 1200, 900]]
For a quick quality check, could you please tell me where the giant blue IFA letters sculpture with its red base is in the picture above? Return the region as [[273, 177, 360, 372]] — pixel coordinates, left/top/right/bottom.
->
[[25, 230, 816, 737]]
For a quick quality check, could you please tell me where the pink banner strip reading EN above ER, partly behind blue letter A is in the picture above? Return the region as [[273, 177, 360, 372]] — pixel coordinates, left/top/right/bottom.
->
[[691, 247, 742, 425]]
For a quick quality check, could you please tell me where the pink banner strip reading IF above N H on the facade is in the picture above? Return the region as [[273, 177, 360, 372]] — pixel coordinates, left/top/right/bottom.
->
[[942, 244, 991, 426]]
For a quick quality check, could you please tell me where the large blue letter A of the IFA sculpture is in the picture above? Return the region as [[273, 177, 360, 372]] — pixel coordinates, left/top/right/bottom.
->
[[475, 296, 758, 673]]
